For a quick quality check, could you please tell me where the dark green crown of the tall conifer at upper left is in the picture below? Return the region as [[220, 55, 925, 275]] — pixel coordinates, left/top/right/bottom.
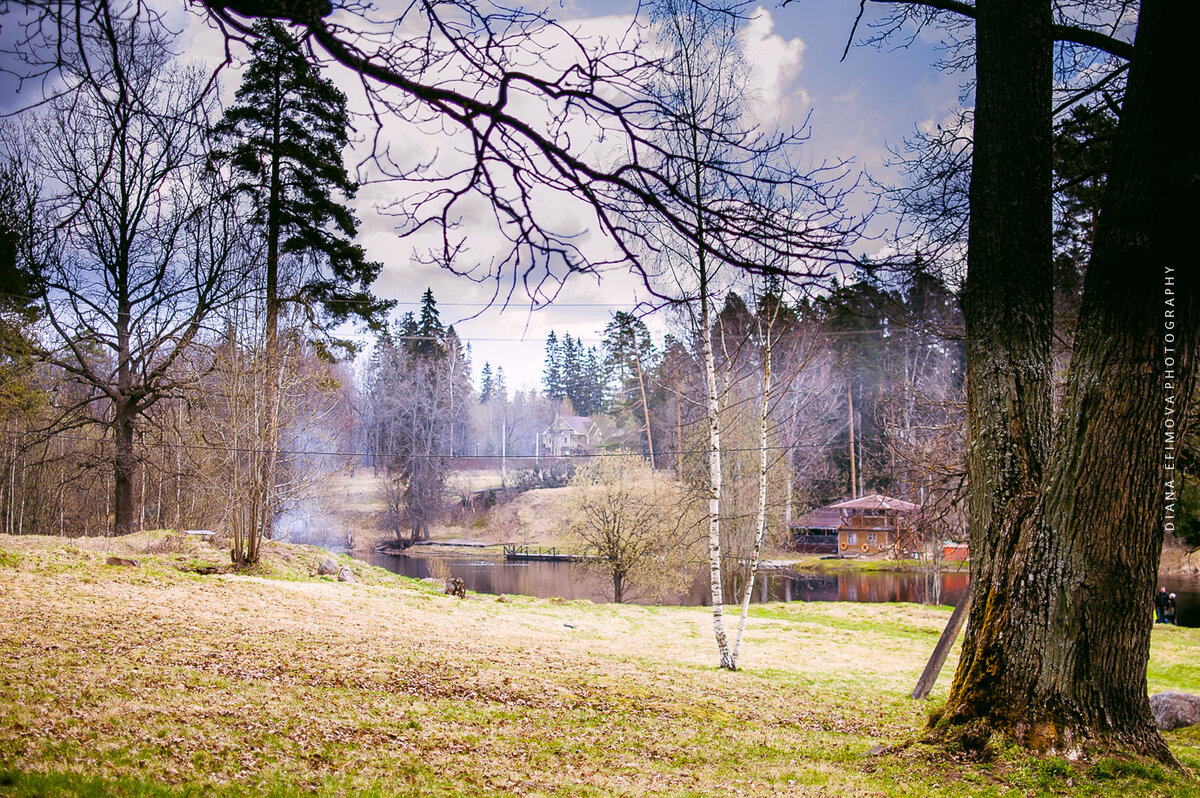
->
[[215, 20, 390, 349]]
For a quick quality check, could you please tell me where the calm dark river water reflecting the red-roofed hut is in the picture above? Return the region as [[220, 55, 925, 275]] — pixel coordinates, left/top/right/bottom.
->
[[371, 553, 1200, 626]]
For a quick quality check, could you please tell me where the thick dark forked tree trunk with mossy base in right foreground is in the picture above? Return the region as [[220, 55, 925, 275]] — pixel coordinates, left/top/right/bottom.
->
[[948, 0, 1200, 760]]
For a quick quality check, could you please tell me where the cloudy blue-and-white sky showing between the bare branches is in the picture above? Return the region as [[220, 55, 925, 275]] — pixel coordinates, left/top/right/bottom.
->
[[0, 0, 962, 390]]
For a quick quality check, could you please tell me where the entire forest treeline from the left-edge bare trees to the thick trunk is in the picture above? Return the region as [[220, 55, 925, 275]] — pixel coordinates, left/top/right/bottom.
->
[[0, 6, 964, 562]]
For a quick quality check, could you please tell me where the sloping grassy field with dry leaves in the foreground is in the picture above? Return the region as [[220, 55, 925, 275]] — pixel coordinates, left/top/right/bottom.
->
[[0, 533, 1200, 797]]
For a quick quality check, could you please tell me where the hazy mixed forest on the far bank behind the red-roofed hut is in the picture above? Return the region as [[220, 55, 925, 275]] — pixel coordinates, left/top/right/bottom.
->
[[352, 275, 965, 541]]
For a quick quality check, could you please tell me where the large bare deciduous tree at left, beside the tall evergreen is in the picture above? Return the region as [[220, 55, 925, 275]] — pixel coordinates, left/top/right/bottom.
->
[[26, 18, 239, 534]]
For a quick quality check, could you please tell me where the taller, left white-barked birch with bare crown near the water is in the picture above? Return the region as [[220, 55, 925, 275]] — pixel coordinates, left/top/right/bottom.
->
[[640, 0, 853, 670]]
